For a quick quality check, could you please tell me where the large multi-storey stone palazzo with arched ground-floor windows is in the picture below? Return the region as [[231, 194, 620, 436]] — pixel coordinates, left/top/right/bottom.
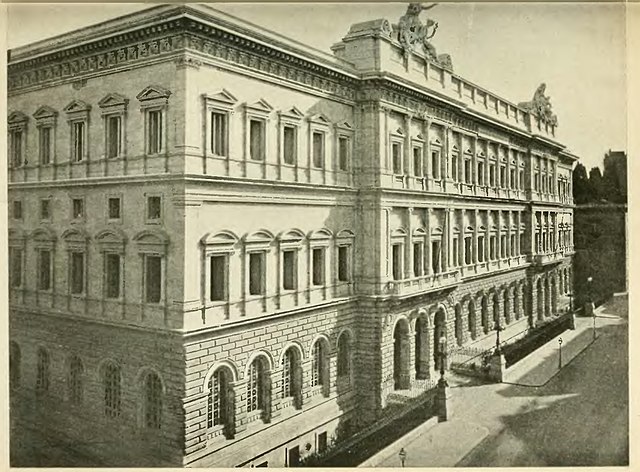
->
[[8, 5, 577, 467]]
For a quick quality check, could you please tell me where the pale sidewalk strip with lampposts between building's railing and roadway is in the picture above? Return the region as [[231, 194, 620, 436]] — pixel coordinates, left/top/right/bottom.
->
[[359, 300, 622, 467]]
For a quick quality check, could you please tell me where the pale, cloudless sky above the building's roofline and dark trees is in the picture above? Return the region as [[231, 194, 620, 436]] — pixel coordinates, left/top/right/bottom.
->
[[6, 3, 627, 169]]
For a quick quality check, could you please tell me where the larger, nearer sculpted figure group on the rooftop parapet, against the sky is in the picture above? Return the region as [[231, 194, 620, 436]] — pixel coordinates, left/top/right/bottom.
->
[[397, 3, 453, 70]]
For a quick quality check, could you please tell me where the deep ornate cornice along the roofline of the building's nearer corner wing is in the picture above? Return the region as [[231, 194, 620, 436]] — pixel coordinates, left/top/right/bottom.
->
[[8, 13, 358, 100]]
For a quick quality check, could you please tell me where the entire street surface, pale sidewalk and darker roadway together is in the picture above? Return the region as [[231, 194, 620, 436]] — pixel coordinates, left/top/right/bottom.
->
[[370, 300, 629, 467]]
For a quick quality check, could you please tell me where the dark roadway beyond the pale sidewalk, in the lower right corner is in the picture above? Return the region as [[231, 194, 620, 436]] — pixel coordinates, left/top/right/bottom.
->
[[457, 308, 629, 467]]
